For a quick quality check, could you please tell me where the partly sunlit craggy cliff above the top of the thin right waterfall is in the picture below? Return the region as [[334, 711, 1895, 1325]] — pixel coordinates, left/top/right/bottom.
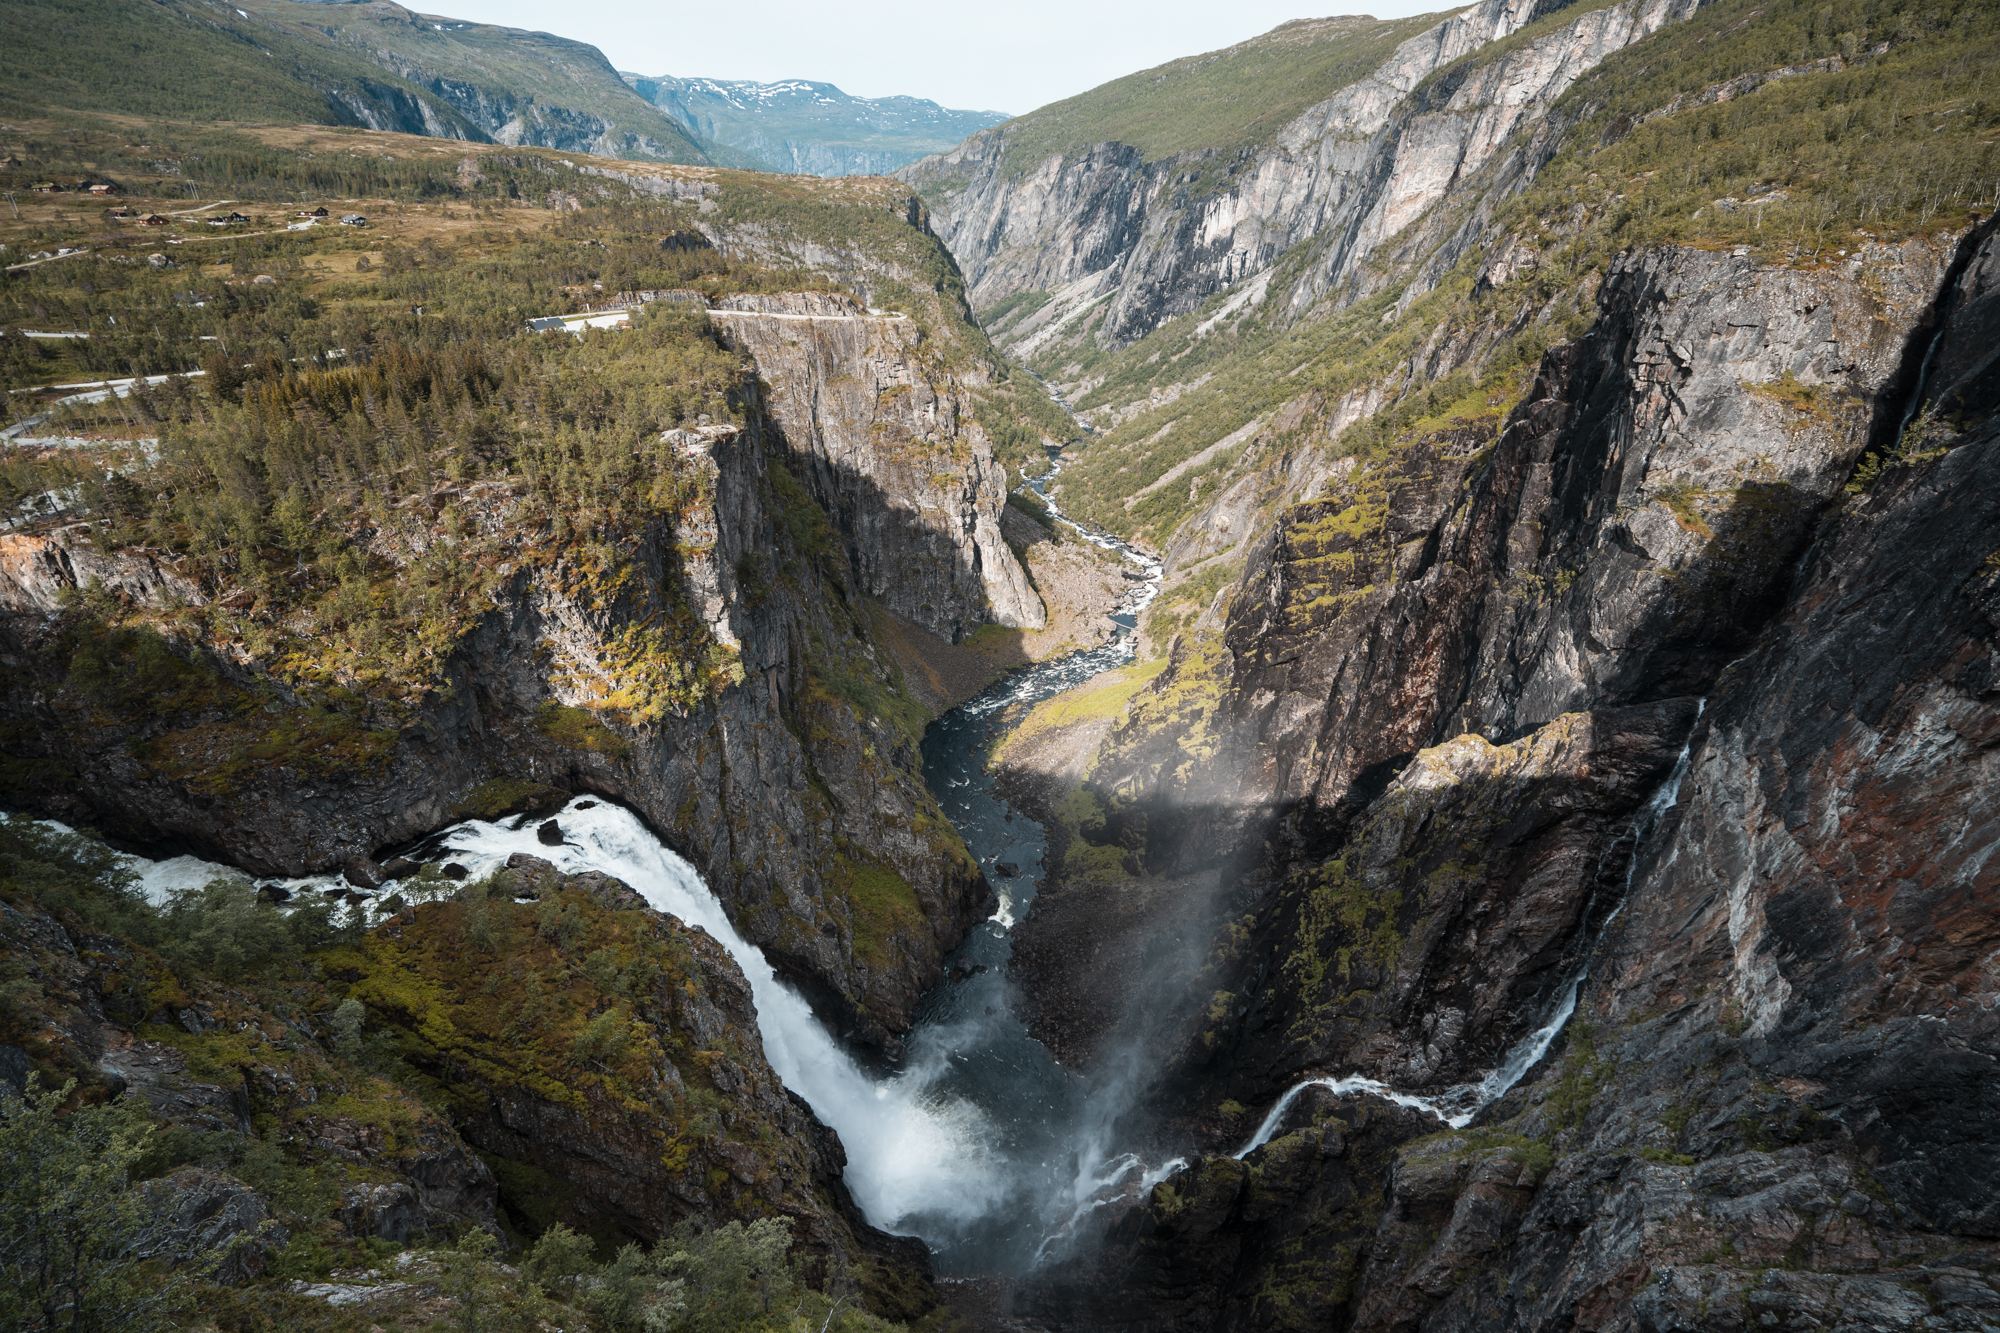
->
[[1102, 230, 1952, 872]]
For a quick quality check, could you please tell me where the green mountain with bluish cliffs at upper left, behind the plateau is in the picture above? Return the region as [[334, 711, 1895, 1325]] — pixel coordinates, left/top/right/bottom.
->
[[0, 0, 708, 162]]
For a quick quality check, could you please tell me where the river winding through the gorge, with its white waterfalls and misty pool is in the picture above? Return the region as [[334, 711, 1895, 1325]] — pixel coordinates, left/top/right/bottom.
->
[[62, 454, 1686, 1277]]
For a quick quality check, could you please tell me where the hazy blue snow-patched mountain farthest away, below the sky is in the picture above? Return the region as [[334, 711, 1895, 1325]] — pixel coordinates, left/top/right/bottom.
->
[[622, 74, 1008, 176]]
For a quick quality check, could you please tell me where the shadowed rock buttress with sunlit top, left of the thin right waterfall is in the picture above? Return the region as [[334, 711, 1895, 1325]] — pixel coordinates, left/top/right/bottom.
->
[[1180, 699, 1698, 1101]]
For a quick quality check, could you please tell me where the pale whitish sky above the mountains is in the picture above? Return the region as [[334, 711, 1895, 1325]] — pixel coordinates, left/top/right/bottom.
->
[[434, 0, 1462, 116]]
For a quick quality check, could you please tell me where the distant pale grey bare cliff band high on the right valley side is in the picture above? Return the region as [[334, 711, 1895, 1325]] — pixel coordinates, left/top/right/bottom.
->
[[898, 0, 1696, 352]]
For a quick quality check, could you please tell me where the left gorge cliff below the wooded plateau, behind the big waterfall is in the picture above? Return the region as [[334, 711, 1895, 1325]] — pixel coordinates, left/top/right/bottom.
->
[[4, 316, 1000, 1045]]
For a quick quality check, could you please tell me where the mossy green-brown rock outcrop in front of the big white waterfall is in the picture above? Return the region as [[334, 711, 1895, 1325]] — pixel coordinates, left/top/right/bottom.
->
[[344, 857, 928, 1283]]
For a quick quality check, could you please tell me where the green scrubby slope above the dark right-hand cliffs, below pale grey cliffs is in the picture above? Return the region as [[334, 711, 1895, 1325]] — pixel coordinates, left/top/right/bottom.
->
[[1032, 0, 2000, 542]]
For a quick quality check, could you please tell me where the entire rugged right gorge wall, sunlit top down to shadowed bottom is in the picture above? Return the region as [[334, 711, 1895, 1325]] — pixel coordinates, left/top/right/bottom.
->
[[1030, 195, 2000, 1333]]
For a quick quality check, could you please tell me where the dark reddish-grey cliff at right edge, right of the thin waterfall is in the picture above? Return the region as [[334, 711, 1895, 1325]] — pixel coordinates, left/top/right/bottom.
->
[[1304, 241, 2000, 1331]]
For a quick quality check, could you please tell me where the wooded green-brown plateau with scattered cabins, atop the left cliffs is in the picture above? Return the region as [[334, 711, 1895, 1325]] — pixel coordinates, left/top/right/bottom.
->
[[0, 120, 1052, 721]]
